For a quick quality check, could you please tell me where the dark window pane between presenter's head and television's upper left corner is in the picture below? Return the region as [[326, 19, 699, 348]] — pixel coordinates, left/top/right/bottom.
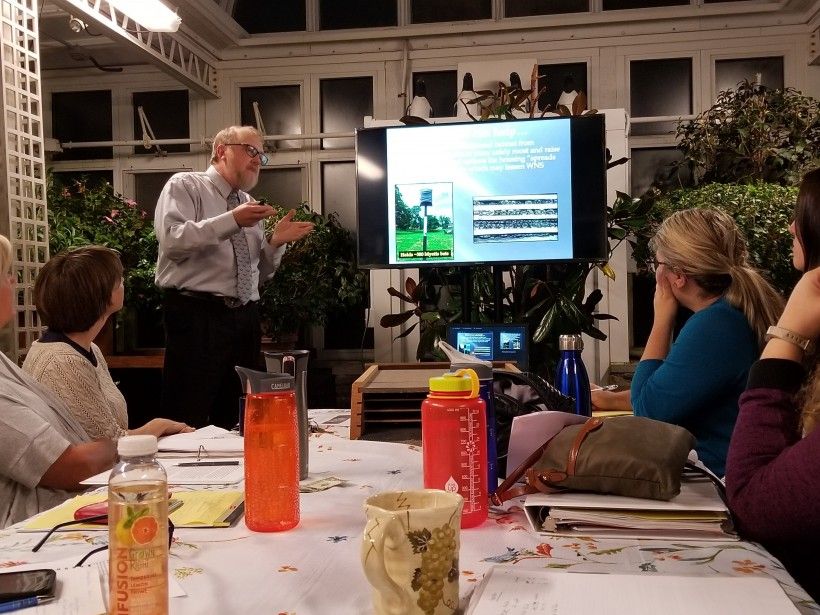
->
[[319, 77, 373, 149]]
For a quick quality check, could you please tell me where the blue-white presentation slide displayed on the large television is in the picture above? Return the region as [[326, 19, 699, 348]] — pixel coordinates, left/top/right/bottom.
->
[[386, 121, 573, 265]]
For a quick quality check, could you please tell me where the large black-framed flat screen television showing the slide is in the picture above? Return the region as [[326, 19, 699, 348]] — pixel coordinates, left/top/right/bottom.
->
[[356, 114, 607, 269]]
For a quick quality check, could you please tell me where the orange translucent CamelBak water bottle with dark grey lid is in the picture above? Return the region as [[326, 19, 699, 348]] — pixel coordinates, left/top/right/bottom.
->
[[236, 367, 299, 532]]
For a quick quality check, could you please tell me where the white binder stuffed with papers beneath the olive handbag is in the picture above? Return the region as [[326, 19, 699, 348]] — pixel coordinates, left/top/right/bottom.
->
[[524, 480, 737, 540]]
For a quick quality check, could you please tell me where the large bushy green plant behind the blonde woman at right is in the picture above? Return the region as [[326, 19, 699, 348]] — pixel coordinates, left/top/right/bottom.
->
[[634, 81, 820, 295]]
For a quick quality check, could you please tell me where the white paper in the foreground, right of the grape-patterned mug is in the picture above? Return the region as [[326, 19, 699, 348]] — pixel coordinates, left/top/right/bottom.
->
[[466, 566, 798, 615]]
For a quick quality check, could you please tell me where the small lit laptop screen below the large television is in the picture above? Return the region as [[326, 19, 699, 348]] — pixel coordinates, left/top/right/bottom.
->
[[447, 324, 529, 370]]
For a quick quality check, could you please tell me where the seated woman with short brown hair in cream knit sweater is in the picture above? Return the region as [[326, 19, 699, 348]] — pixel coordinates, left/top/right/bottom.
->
[[23, 246, 193, 439]]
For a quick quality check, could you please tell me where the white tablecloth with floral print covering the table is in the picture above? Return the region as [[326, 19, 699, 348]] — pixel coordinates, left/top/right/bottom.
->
[[0, 411, 820, 615]]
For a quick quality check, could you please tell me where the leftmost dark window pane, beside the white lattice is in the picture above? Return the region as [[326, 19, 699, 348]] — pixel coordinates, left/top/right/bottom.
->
[[51, 90, 114, 160]]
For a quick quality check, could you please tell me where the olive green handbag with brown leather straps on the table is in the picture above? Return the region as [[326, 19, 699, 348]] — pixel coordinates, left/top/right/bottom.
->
[[491, 416, 695, 505]]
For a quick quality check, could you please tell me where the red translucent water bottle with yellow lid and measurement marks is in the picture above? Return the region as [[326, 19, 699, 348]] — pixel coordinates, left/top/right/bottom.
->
[[421, 369, 487, 528]]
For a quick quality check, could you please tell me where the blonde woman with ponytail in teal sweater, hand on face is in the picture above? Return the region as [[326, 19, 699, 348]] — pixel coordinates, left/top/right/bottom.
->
[[592, 209, 783, 476]]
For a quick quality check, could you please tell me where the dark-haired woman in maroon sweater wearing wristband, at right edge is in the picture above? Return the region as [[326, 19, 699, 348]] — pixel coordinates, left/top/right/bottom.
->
[[726, 169, 820, 600]]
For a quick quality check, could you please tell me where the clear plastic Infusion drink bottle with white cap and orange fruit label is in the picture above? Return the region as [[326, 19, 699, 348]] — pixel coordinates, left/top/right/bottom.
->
[[108, 436, 168, 615]]
